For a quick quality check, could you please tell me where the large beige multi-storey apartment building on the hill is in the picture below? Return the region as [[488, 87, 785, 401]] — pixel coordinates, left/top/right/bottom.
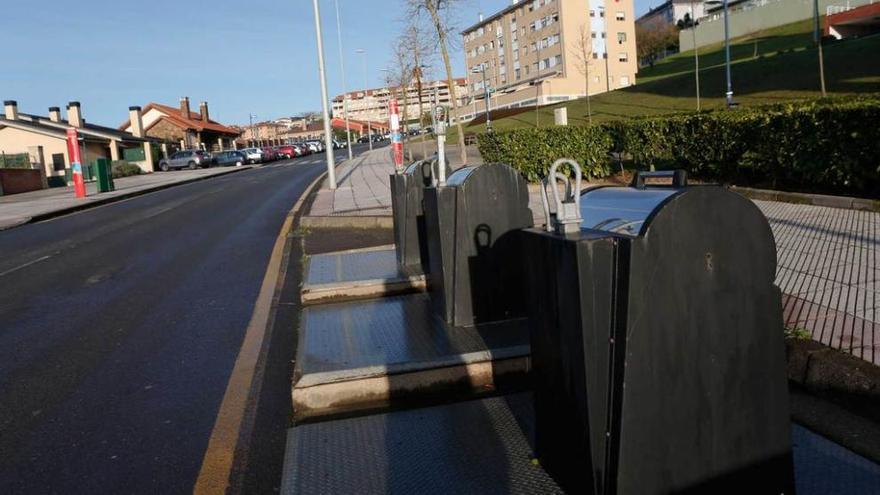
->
[[459, 0, 638, 120]]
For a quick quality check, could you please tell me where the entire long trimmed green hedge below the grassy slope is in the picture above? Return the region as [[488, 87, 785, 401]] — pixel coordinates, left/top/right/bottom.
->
[[479, 96, 880, 196]]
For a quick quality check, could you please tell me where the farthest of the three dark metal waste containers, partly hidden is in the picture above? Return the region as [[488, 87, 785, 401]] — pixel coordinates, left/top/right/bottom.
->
[[390, 157, 451, 273]]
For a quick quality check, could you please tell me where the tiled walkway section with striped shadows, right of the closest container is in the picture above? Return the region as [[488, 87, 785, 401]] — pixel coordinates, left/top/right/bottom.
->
[[755, 201, 880, 365]]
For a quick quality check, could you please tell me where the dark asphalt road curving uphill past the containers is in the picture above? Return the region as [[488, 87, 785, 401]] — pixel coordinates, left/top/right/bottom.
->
[[0, 147, 363, 493]]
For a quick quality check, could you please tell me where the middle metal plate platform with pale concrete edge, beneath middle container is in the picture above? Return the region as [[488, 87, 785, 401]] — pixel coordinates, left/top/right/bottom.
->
[[292, 294, 530, 420]]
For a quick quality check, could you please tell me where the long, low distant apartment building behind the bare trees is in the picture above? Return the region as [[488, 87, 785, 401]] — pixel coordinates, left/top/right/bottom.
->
[[333, 78, 468, 123]]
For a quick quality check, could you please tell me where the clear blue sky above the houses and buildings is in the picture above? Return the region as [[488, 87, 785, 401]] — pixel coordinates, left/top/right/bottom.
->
[[0, 0, 662, 126]]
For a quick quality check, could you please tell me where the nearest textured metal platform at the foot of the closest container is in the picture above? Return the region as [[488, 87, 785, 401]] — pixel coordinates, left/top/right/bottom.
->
[[281, 394, 880, 495]]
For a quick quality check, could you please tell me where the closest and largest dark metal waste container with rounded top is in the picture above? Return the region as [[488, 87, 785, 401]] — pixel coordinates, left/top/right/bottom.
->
[[523, 174, 794, 494]]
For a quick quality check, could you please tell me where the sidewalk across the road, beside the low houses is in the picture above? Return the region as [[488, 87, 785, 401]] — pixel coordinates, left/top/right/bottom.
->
[[0, 166, 251, 230]]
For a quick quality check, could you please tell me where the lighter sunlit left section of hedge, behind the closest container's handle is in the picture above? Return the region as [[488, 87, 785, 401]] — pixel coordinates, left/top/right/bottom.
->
[[477, 126, 614, 182]]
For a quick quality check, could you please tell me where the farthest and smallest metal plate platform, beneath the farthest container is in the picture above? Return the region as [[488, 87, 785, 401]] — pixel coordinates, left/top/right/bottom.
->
[[301, 246, 425, 304]]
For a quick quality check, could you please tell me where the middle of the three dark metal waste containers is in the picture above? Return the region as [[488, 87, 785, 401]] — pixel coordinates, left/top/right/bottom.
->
[[424, 164, 533, 326]]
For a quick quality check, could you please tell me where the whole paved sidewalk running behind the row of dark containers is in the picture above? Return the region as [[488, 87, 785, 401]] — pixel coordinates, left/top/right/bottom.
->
[[309, 148, 880, 365]]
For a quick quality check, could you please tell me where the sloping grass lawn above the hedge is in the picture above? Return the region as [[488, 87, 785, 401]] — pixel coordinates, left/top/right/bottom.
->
[[448, 22, 880, 143]]
